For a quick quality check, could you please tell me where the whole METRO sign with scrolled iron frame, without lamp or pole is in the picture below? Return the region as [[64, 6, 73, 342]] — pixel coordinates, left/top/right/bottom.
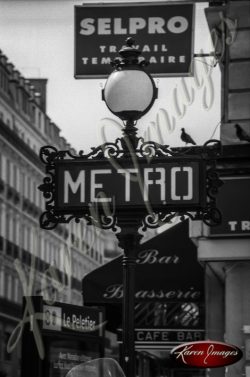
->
[[38, 141, 221, 231]]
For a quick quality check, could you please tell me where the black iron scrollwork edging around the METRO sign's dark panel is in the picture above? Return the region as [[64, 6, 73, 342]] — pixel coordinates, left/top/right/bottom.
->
[[39, 134, 222, 230]]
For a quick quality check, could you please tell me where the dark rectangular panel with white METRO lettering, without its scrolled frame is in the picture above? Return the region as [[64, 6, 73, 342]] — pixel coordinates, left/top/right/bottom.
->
[[55, 157, 206, 213]]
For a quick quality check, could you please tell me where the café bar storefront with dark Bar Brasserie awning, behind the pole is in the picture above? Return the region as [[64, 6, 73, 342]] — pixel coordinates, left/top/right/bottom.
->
[[83, 221, 205, 377]]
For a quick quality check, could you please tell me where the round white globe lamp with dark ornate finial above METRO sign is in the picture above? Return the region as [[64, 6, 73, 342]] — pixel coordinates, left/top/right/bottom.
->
[[102, 38, 157, 124]]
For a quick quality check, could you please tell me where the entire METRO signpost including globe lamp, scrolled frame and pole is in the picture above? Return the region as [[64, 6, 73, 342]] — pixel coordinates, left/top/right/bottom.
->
[[39, 39, 221, 377]]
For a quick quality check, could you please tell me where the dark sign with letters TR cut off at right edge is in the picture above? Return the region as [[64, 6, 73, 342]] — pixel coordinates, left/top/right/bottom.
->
[[209, 177, 250, 237]]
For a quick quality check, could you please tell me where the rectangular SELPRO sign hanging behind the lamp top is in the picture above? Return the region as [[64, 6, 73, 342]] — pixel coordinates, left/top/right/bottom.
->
[[74, 3, 194, 78]]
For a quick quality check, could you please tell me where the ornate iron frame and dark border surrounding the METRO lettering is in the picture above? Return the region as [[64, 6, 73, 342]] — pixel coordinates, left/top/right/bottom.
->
[[39, 137, 222, 231]]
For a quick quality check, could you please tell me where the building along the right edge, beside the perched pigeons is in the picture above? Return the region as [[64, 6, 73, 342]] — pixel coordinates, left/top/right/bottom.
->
[[191, 0, 250, 377]]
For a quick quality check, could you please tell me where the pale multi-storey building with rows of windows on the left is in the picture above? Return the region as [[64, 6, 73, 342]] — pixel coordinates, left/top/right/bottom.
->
[[0, 52, 109, 377]]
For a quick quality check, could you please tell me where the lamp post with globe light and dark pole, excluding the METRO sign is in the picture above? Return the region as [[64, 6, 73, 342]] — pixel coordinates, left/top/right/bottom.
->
[[102, 38, 157, 377]]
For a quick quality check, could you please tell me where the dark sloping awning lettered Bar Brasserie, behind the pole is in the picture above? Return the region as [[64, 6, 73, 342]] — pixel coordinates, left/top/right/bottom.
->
[[82, 221, 204, 305]]
